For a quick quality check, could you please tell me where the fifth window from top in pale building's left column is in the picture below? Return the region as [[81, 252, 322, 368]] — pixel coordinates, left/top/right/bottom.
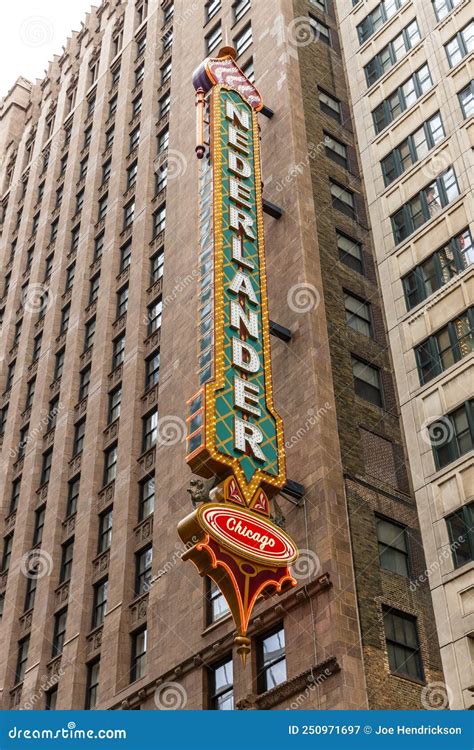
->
[[390, 167, 459, 245]]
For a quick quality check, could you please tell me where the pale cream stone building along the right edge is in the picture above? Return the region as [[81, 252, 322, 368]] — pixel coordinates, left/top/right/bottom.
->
[[337, 0, 474, 708]]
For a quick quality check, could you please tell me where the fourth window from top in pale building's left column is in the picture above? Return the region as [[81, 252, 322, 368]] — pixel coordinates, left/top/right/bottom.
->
[[380, 112, 445, 185]]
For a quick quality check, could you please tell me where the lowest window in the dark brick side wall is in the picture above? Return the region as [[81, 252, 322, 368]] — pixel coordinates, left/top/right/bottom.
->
[[383, 609, 424, 680]]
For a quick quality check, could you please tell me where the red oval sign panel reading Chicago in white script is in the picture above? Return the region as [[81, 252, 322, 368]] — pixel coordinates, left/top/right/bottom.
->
[[199, 505, 298, 565]]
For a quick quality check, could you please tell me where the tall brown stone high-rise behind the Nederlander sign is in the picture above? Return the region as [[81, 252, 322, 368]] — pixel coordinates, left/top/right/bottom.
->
[[0, 0, 443, 709]]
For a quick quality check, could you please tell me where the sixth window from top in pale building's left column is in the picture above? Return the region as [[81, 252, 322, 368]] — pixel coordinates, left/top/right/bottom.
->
[[402, 229, 474, 310]]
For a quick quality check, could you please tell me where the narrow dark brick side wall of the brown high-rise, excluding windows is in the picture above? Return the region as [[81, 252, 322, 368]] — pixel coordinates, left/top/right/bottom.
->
[[294, 0, 442, 708]]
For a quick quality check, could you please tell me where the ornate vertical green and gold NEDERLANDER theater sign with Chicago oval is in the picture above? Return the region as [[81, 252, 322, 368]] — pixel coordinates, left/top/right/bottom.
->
[[178, 47, 298, 663]]
